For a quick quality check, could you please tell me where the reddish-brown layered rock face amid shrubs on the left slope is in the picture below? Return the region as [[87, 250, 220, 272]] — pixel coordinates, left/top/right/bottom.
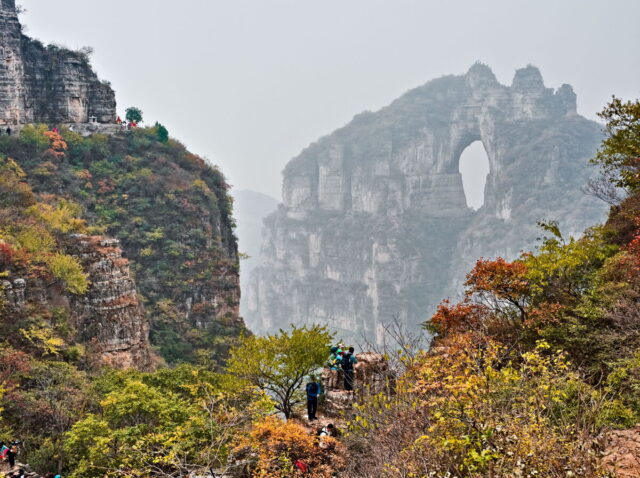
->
[[0, 235, 153, 370]]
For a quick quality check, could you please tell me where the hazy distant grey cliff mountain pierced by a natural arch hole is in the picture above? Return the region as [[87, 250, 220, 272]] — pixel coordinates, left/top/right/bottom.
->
[[247, 64, 605, 339]]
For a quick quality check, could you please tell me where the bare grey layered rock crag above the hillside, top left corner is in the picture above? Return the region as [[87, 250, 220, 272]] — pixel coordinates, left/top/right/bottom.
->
[[0, 0, 116, 125]]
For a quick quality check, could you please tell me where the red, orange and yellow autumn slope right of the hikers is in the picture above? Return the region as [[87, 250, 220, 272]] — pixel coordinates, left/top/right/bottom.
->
[[340, 99, 640, 478]]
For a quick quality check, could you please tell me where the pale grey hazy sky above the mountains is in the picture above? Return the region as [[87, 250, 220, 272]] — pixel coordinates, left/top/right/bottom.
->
[[18, 0, 640, 197]]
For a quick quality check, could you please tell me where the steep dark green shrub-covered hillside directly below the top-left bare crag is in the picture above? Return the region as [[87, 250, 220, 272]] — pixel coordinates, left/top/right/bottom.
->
[[0, 125, 245, 362]]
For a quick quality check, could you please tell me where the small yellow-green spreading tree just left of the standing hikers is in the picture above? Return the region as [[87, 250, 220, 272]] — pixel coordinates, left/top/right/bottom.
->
[[228, 325, 333, 418]]
